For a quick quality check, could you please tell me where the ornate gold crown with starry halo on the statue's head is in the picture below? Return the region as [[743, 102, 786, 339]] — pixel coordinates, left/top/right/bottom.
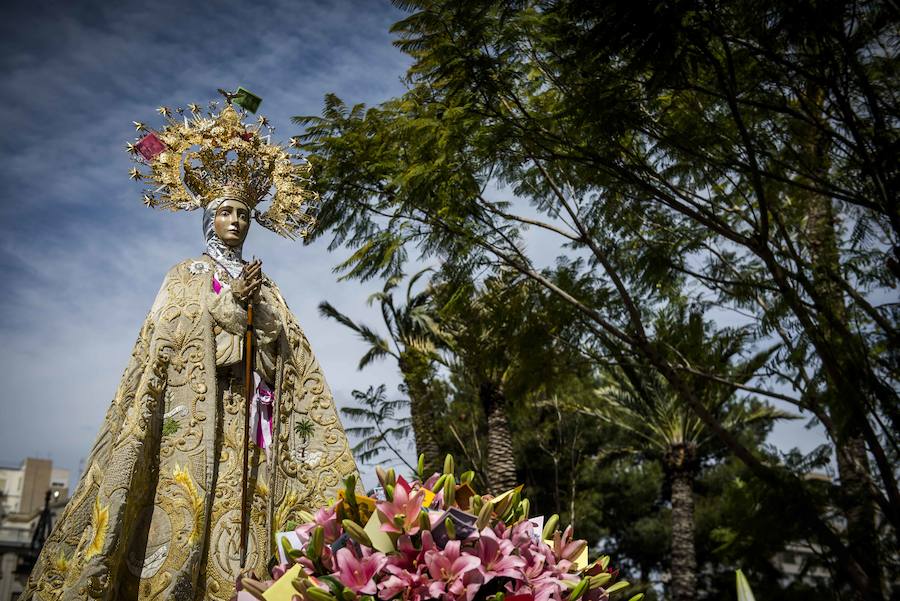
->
[[126, 88, 319, 239]]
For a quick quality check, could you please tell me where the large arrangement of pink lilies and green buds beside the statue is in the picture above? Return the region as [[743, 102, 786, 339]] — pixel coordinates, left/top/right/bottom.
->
[[238, 455, 643, 601]]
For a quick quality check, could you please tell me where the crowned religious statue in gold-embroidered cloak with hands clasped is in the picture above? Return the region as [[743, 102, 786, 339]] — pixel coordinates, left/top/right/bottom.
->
[[21, 96, 356, 601]]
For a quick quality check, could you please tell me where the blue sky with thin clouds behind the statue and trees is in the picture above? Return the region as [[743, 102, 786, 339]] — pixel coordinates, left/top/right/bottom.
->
[[0, 0, 821, 492]]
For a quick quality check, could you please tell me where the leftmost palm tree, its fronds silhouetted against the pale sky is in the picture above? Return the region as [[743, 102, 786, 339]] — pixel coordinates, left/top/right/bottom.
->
[[319, 269, 442, 469]]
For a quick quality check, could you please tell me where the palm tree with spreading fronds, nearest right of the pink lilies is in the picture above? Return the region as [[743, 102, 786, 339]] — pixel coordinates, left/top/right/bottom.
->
[[579, 306, 790, 601]]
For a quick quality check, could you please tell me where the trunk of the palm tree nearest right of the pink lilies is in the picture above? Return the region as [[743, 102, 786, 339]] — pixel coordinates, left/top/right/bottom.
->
[[669, 454, 697, 601]]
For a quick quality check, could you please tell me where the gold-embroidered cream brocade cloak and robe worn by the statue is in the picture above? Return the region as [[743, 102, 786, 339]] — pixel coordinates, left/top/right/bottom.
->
[[21, 257, 356, 601]]
